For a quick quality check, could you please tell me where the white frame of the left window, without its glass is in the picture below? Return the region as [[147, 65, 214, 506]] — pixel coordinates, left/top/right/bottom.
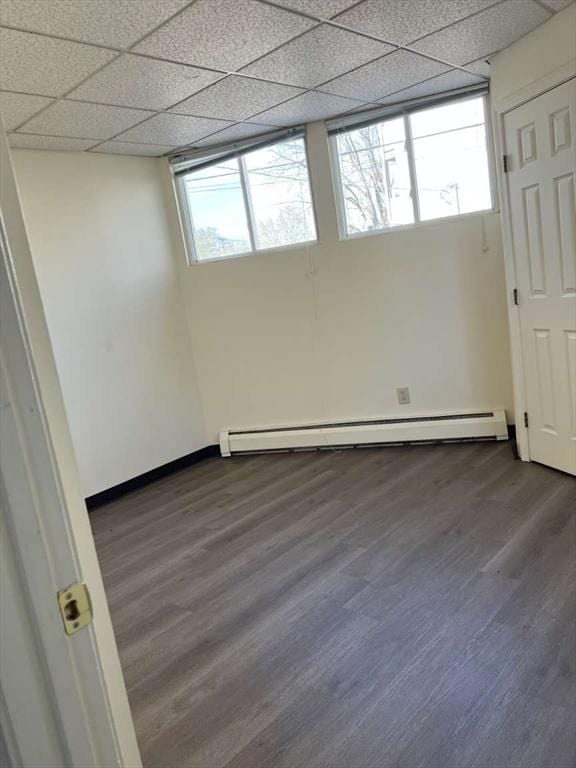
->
[[172, 132, 319, 267]]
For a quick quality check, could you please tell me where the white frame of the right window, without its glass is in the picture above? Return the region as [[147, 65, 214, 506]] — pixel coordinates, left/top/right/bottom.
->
[[328, 92, 500, 240]]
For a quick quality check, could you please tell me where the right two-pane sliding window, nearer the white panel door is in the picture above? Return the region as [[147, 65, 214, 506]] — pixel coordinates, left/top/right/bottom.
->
[[333, 96, 492, 236]]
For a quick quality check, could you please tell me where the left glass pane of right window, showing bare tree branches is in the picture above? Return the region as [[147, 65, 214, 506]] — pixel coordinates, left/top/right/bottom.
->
[[337, 118, 414, 235]]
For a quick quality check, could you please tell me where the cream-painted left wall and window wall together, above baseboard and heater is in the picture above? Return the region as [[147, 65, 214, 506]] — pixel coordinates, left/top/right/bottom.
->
[[14, 113, 512, 476]]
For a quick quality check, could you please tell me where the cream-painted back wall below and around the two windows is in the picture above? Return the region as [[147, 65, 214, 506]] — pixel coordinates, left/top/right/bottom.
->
[[165, 123, 512, 442]]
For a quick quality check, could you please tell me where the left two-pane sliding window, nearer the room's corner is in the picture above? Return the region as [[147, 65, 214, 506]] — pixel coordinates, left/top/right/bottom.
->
[[178, 137, 316, 261]]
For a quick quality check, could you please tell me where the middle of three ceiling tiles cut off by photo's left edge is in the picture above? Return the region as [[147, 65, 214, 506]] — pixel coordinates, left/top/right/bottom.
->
[[0, 29, 115, 96]]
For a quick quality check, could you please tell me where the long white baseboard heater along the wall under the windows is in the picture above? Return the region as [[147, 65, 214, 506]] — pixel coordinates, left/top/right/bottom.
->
[[220, 409, 508, 456]]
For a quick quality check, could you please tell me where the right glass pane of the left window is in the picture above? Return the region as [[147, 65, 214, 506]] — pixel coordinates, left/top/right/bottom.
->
[[244, 138, 316, 249]]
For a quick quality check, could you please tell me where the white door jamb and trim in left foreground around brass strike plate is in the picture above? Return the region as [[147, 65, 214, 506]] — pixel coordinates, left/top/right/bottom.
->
[[0, 120, 141, 768]]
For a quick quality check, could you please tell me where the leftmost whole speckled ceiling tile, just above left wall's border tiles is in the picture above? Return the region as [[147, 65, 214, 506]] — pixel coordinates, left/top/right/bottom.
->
[[20, 101, 153, 139]]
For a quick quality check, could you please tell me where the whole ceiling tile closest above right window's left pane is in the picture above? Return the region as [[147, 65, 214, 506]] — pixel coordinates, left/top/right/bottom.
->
[[321, 51, 450, 101]]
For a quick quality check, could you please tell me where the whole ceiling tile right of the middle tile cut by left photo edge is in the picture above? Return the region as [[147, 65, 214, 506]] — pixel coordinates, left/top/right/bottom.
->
[[69, 54, 222, 110]]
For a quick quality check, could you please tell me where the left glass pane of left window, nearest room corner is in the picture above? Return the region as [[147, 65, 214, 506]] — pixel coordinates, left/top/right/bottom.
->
[[184, 158, 250, 261]]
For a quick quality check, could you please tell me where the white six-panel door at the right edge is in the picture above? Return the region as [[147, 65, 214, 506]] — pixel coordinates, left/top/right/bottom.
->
[[504, 79, 576, 474]]
